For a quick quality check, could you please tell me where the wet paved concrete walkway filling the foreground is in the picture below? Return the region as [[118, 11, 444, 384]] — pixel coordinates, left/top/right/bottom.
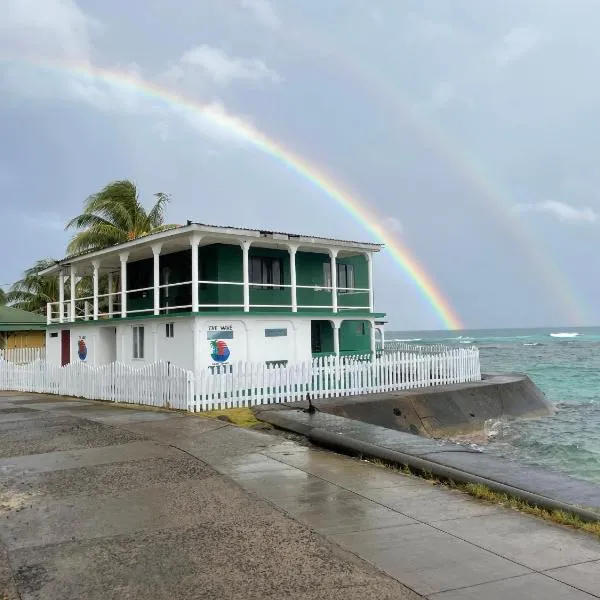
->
[[0, 393, 600, 600]]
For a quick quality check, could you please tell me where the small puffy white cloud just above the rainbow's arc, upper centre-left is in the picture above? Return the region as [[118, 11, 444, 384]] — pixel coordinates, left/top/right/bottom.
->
[[180, 45, 281, 84]]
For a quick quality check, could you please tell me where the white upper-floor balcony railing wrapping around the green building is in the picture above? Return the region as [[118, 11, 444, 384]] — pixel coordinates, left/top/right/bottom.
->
[[47, 281, 369, 324]]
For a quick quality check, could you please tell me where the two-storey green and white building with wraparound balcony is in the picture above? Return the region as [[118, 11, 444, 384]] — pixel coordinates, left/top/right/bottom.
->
[[43, 222, 385, 373]]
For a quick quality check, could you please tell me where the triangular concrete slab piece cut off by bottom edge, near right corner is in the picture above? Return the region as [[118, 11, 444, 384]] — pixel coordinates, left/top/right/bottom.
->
[[429, 573, 597, 600]]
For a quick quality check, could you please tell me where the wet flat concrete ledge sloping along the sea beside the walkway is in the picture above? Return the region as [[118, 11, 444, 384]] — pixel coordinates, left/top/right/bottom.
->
[[256, 405, 600, 512]]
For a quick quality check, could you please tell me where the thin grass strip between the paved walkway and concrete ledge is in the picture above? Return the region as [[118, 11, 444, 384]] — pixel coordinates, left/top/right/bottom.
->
[[359, 456, 600, 538]]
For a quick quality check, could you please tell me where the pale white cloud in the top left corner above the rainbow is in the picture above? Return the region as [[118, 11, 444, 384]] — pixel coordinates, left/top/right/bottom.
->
[[0, 0, 102, 61]]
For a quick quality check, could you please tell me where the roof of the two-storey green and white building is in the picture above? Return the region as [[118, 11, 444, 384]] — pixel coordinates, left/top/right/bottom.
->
[[41, 221, 383, 275]]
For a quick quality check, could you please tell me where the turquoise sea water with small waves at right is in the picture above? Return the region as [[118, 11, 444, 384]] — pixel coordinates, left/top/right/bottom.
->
[[386, 327, 600, 482]]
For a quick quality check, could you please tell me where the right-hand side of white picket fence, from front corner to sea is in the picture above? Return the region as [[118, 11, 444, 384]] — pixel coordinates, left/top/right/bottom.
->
[[190, 348, 481, 412]]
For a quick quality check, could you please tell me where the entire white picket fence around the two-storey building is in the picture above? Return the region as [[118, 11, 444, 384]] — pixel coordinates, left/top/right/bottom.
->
[[0, 348, 481, 412]]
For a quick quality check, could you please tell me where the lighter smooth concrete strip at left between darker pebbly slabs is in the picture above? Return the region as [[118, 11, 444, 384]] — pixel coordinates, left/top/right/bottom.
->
[[0, 441, 180, 475]]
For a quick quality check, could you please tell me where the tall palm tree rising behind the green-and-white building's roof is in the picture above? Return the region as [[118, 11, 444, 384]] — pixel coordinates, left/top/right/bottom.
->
[[65, 180, 176, 254]]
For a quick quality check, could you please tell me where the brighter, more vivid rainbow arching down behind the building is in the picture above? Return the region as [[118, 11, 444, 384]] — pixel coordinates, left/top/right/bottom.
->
[[0, 58, 464, 329]]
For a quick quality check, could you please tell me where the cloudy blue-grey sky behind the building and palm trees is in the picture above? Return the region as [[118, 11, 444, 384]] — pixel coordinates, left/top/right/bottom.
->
[[0, 0, 600, 330]]
